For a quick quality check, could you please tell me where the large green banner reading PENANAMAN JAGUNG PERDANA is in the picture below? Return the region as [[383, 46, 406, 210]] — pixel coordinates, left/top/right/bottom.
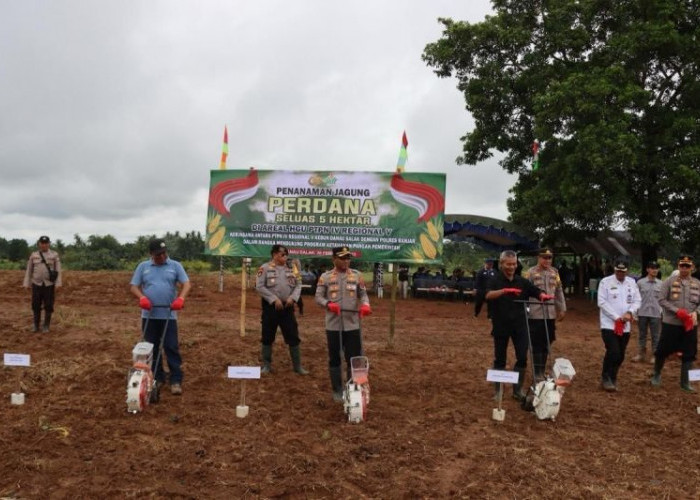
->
[[205, 169, 445, 264]]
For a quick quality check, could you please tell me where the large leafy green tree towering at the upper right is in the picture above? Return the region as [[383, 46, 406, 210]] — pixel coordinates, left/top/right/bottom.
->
[[423, 0, 700, 260]]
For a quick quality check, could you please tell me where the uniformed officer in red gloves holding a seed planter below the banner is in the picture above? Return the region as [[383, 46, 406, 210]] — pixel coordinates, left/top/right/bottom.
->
[[316, 246, 372, 402]]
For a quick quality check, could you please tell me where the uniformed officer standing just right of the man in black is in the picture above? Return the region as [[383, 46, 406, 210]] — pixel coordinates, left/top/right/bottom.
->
[[523, 248, 566, 380]]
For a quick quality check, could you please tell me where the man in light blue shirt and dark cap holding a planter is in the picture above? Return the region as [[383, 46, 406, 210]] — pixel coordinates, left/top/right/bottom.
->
[[131, 239, 192, 395]]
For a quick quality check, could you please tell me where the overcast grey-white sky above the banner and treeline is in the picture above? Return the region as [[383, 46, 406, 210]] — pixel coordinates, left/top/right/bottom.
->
[[0, 0, 515, 242]]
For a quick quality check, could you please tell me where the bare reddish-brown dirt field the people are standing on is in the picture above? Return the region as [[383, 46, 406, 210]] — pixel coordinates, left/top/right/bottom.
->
[[0, 271, 700, 499]]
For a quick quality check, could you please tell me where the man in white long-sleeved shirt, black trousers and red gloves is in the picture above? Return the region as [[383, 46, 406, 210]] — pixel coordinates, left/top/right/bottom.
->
[[598, 262, 642, 392]]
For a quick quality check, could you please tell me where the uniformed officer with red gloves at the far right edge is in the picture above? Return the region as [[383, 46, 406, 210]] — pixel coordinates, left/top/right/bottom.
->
[[651, 255, 700, 392]]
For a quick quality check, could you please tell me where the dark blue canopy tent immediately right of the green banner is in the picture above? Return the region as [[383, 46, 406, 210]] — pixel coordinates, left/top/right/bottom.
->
[[443, 214, 539, 251]]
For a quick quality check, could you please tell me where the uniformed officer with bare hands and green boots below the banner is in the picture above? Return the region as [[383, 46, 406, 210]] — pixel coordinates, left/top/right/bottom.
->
[[255, 245, 309, 375]]
